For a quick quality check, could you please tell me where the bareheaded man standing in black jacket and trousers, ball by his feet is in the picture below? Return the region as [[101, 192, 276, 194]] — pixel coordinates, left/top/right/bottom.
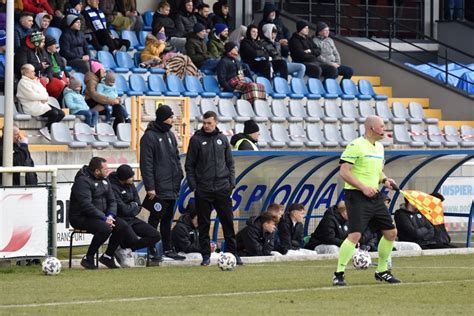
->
[[185, 111, 242, 266]]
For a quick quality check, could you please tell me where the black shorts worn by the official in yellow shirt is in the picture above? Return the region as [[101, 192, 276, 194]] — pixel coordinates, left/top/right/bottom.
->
[[344, 190, 395, 233]]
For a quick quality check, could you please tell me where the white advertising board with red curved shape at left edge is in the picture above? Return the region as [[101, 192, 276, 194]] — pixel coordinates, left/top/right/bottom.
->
[[0, 188, 48, 258]]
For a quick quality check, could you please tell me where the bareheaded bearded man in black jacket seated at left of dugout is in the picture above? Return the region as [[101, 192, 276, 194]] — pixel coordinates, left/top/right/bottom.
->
[[70, 157, 127, 269]]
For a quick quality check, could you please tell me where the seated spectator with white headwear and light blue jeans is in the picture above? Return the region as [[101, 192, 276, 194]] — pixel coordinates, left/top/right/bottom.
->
[[262, 24, 306, 79]]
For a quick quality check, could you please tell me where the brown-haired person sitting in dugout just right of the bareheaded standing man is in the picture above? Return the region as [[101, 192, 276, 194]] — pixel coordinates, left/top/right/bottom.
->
[[237, 212, 278, 257]]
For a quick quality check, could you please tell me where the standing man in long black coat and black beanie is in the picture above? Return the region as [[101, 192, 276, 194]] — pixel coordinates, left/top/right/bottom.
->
[[140, 105, 185, 260]]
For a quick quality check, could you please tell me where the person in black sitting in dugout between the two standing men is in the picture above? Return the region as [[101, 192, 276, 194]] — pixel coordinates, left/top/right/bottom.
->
[[171, 203, 201, 254]]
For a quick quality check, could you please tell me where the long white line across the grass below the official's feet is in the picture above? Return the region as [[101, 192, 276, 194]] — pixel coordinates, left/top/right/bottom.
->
[[0, 279, 474, 309]]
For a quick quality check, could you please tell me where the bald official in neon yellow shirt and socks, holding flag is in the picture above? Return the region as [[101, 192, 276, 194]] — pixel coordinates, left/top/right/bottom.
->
[[333, 116, 400, 286]]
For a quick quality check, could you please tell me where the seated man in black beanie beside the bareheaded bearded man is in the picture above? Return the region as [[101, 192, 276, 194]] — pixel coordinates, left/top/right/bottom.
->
[[108, 165, 161, 267]]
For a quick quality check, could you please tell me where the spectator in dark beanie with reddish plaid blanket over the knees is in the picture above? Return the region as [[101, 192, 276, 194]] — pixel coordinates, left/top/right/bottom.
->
[[216, 42, 267, 104]]
